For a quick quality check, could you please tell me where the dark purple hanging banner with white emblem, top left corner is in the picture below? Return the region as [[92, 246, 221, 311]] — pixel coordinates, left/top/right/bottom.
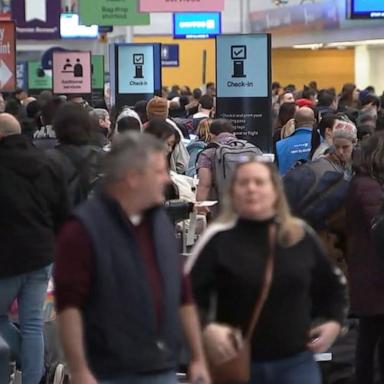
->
[[12, 0, 61, 40]]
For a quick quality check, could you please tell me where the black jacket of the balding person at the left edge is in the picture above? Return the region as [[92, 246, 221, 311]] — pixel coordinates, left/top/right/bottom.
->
[[0, 135, 68, 278]]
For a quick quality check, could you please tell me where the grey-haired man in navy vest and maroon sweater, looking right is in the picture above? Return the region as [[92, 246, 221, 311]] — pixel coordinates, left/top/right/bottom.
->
[[54, 133, 210, 384]]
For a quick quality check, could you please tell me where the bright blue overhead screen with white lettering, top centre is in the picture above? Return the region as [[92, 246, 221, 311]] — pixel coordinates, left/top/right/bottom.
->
[[173, 12, 221, 39]]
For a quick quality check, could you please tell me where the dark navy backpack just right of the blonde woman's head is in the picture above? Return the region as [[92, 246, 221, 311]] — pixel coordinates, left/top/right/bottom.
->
[[283, 158, 349, 229]]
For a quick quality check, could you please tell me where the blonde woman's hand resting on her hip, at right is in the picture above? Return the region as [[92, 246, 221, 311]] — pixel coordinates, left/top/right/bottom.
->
[[307, 321, 341, 353]]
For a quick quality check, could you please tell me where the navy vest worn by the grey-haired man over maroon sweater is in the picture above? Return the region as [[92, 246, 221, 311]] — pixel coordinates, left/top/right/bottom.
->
[[74, 194, 181, 379]]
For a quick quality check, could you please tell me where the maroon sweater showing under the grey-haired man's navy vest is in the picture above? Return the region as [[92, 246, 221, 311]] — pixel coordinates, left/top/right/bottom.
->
[[54, 219, 193, 319]]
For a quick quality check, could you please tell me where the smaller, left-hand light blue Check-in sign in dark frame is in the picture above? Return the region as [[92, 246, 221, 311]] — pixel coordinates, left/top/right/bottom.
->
[[109, 44, 161, 108]]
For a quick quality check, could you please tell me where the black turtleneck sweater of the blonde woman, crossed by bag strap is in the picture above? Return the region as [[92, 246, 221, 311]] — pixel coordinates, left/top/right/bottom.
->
[[191, 219, 348, 360]]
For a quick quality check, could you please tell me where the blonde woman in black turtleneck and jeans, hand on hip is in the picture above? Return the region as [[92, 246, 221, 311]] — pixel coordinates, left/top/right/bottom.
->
[[187, 159, 348, 384]]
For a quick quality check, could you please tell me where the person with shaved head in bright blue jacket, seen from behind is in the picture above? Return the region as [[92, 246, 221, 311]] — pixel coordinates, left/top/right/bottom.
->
[[276, 107, 316, 175]]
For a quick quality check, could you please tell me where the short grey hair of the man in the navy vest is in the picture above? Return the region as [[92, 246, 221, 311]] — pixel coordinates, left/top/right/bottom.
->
[[103, 132, 165, 184]]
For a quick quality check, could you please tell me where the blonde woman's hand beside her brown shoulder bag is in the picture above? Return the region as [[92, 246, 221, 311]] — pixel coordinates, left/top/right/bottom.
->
[[204, 323, 241, 365]]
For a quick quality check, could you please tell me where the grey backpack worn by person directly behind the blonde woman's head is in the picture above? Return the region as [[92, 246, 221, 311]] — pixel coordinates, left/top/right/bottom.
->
[[207, 139, 263, 198]]
